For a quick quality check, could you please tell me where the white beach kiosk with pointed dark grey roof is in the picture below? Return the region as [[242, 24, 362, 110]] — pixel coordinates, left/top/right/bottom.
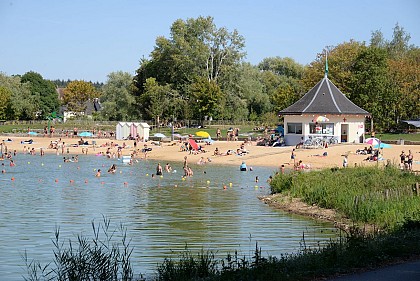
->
[[279, 72, 370, 145]]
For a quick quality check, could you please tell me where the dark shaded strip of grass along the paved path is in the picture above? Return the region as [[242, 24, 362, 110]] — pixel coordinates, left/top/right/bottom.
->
[[154, 221, 420, 281]]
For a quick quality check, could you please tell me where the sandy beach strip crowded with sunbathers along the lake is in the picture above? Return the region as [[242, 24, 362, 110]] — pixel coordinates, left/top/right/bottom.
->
[[2, 136, 420, 171]]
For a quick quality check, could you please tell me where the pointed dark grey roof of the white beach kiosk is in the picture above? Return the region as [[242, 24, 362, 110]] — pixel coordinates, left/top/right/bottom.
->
[[279, 76, 370, 115]]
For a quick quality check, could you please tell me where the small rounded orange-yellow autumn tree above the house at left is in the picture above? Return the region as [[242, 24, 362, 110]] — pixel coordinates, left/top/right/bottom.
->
[[63, 80, 100, 114]]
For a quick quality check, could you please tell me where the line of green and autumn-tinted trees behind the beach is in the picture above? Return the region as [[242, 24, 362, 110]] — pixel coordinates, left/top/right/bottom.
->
[[0, 17, 420, 131]]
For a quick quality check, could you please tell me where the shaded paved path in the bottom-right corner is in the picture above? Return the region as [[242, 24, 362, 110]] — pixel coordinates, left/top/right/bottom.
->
[[329, 260, 420, 281]]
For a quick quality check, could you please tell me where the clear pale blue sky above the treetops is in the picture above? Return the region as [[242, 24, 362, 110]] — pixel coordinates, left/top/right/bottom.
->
[[0, 0, 420, 83]]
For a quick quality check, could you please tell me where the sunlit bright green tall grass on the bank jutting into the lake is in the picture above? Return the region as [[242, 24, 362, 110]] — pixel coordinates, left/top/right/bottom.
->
[[271, 167, 420, 229]]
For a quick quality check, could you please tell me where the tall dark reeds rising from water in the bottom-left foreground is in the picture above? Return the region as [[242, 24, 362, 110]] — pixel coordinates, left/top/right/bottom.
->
[[23, 218, 133, 281]]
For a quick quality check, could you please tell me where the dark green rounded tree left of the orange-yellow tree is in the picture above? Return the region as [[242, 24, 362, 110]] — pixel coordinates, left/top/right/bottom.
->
[[21, 71, 59, 119]]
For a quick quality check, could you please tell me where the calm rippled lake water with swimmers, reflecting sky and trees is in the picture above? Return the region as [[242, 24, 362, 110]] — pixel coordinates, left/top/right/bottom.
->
[[0, 153, 337, 280]]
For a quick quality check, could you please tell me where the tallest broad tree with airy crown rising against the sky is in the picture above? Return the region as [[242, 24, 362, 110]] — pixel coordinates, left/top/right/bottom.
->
[[134, 17, 245, 117]]
